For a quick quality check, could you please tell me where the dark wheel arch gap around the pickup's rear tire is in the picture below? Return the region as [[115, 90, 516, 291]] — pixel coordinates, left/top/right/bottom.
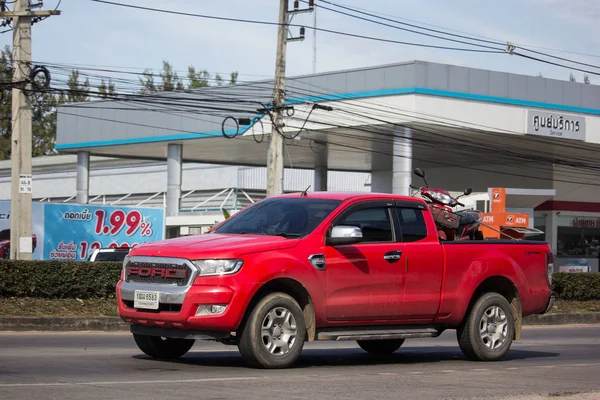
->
[[462, 275, 523, 340]]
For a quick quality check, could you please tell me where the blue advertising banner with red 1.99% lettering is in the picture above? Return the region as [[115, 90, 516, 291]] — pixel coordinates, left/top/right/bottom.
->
[[43, 203, 165, 261]]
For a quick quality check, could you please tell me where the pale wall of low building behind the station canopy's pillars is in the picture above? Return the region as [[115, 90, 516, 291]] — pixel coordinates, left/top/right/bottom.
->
[[0, 157, 369, 204]]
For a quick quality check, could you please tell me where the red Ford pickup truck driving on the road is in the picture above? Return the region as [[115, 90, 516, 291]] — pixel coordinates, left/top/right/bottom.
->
[[117, 192, 554, 368]]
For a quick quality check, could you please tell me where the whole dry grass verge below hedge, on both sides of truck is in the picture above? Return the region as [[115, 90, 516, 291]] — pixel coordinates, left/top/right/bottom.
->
[[0, 297, 600, 317]]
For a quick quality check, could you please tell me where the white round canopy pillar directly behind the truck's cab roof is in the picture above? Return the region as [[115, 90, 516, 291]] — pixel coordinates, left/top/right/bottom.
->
[[392, 127, 412, 196]]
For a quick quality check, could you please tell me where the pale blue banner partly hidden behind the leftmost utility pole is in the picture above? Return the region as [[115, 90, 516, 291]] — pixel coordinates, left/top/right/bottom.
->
[[0, 200, 44, 260]]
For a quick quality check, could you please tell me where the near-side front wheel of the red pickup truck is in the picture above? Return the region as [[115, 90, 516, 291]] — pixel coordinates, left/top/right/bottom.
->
[[238, 293, 306, 368]]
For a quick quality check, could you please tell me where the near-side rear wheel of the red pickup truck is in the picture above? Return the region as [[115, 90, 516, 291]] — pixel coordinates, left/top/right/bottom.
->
[[456, 293, 515, 361]]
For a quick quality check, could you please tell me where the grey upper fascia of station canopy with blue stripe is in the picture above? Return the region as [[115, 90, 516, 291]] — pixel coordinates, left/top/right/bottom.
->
[[57, 61, 600, 147]]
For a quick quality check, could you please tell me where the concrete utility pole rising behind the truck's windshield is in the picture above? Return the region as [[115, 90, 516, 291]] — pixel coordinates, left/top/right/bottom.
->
[[267, 0, 314, 196]]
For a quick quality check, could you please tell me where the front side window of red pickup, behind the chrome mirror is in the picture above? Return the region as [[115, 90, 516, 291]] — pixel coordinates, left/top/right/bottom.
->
[[335, 207, 394, 242]]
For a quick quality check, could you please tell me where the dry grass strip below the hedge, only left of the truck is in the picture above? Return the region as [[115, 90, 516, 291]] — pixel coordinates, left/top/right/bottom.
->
[[0, 297, 117, 317]]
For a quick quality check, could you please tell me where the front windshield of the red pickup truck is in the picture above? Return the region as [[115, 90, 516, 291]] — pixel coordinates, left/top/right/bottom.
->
[[215, 198, 341, 237]]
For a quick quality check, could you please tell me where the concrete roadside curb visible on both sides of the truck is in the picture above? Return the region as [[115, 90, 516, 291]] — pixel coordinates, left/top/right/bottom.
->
[[0, 312, 600, 332]]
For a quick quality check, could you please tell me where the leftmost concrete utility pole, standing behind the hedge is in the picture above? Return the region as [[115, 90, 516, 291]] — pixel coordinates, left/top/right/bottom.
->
[[0, 0, 60, 260]]
